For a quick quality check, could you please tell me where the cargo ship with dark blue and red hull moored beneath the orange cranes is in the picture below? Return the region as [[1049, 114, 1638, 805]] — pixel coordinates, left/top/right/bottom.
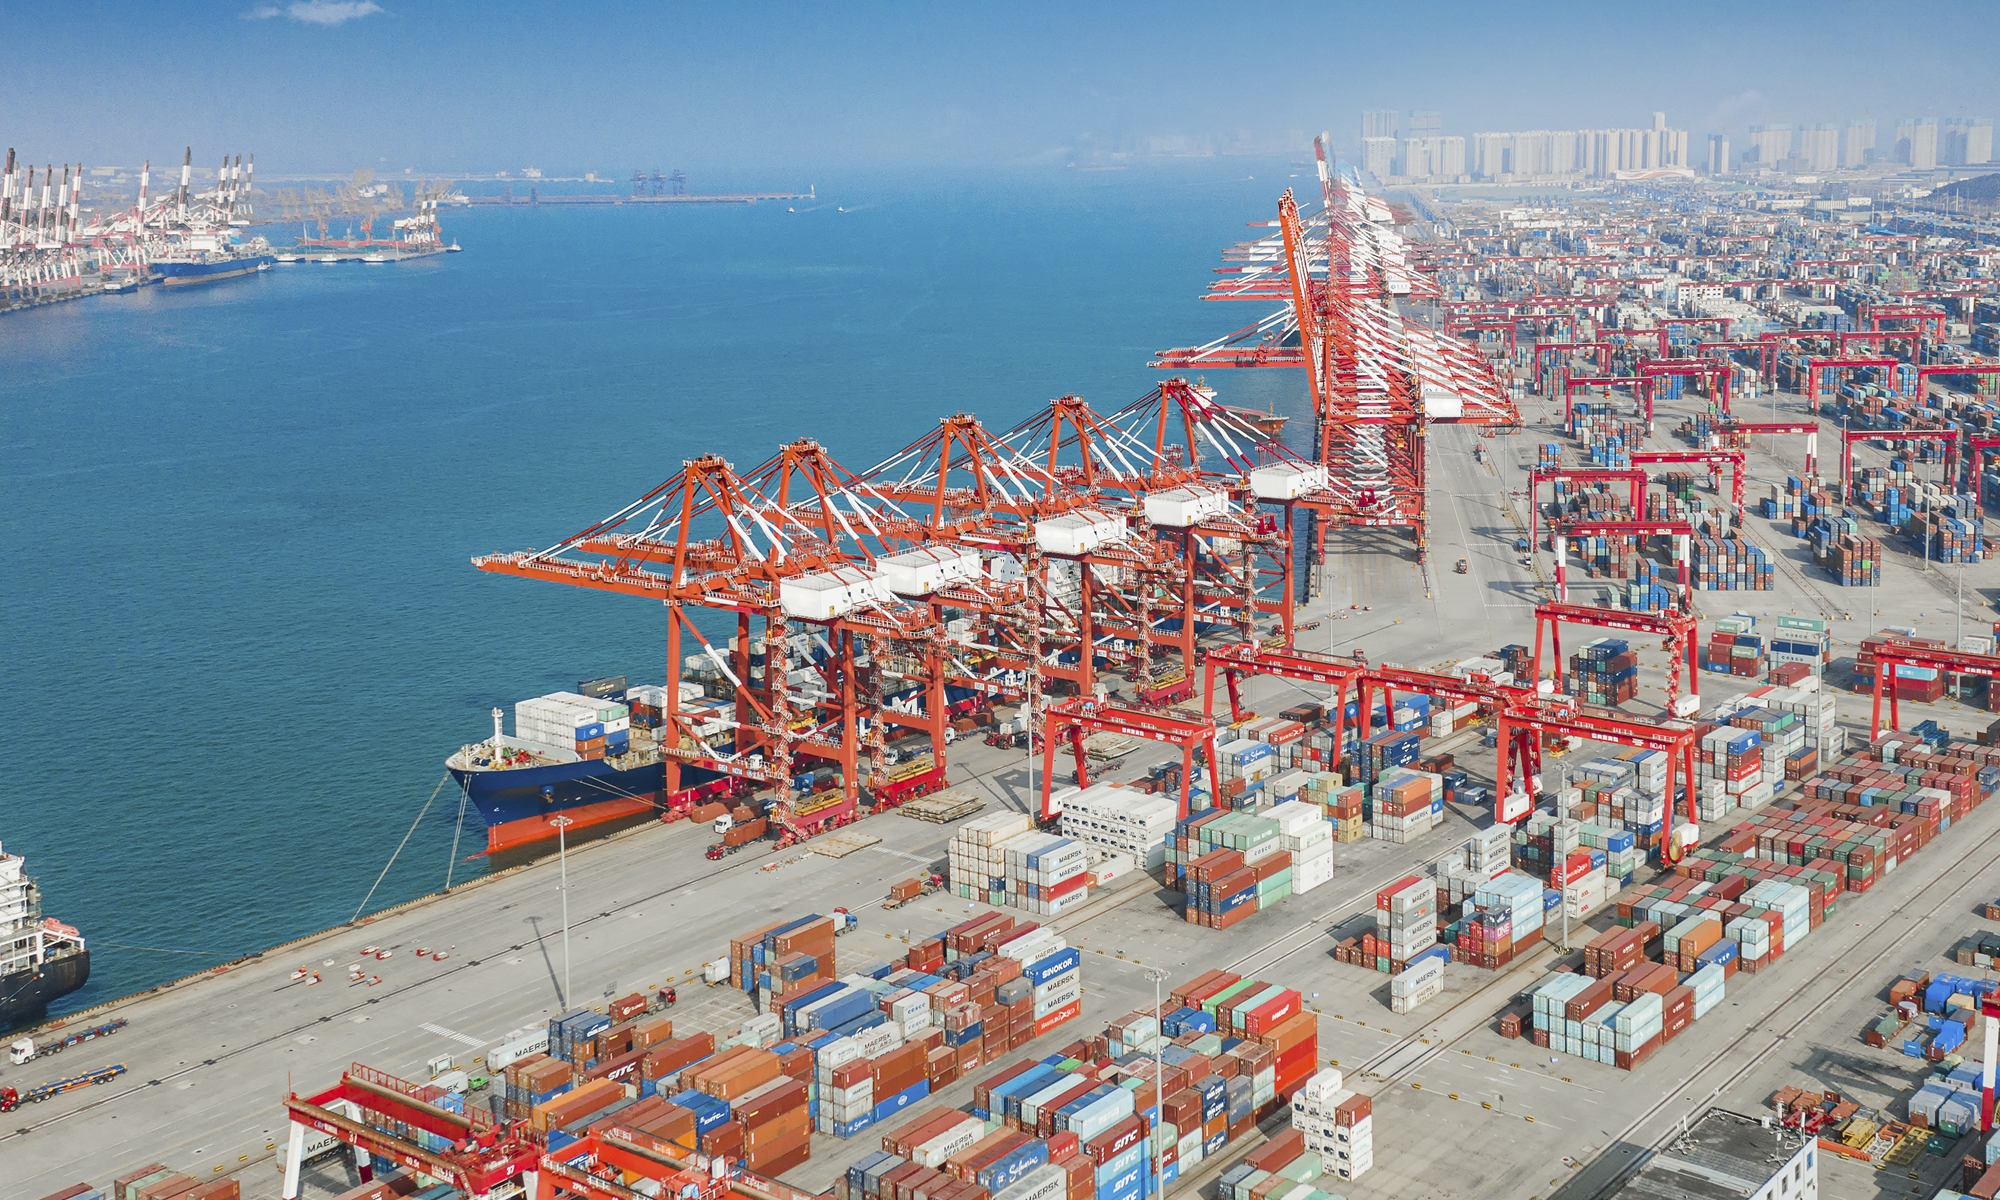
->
[[444, 678, 734, 854]]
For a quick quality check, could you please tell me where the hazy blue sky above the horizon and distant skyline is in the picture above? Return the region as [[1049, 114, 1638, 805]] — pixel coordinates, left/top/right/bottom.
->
[[15, 0, 2000, 178]]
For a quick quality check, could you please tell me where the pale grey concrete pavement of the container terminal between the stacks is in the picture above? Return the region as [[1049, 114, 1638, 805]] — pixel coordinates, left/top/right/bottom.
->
[[11, 406, 2000, 1200]]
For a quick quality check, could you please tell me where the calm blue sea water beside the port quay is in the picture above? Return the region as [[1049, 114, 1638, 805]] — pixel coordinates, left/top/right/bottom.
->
[[0, 160, 1312, 1012]]
